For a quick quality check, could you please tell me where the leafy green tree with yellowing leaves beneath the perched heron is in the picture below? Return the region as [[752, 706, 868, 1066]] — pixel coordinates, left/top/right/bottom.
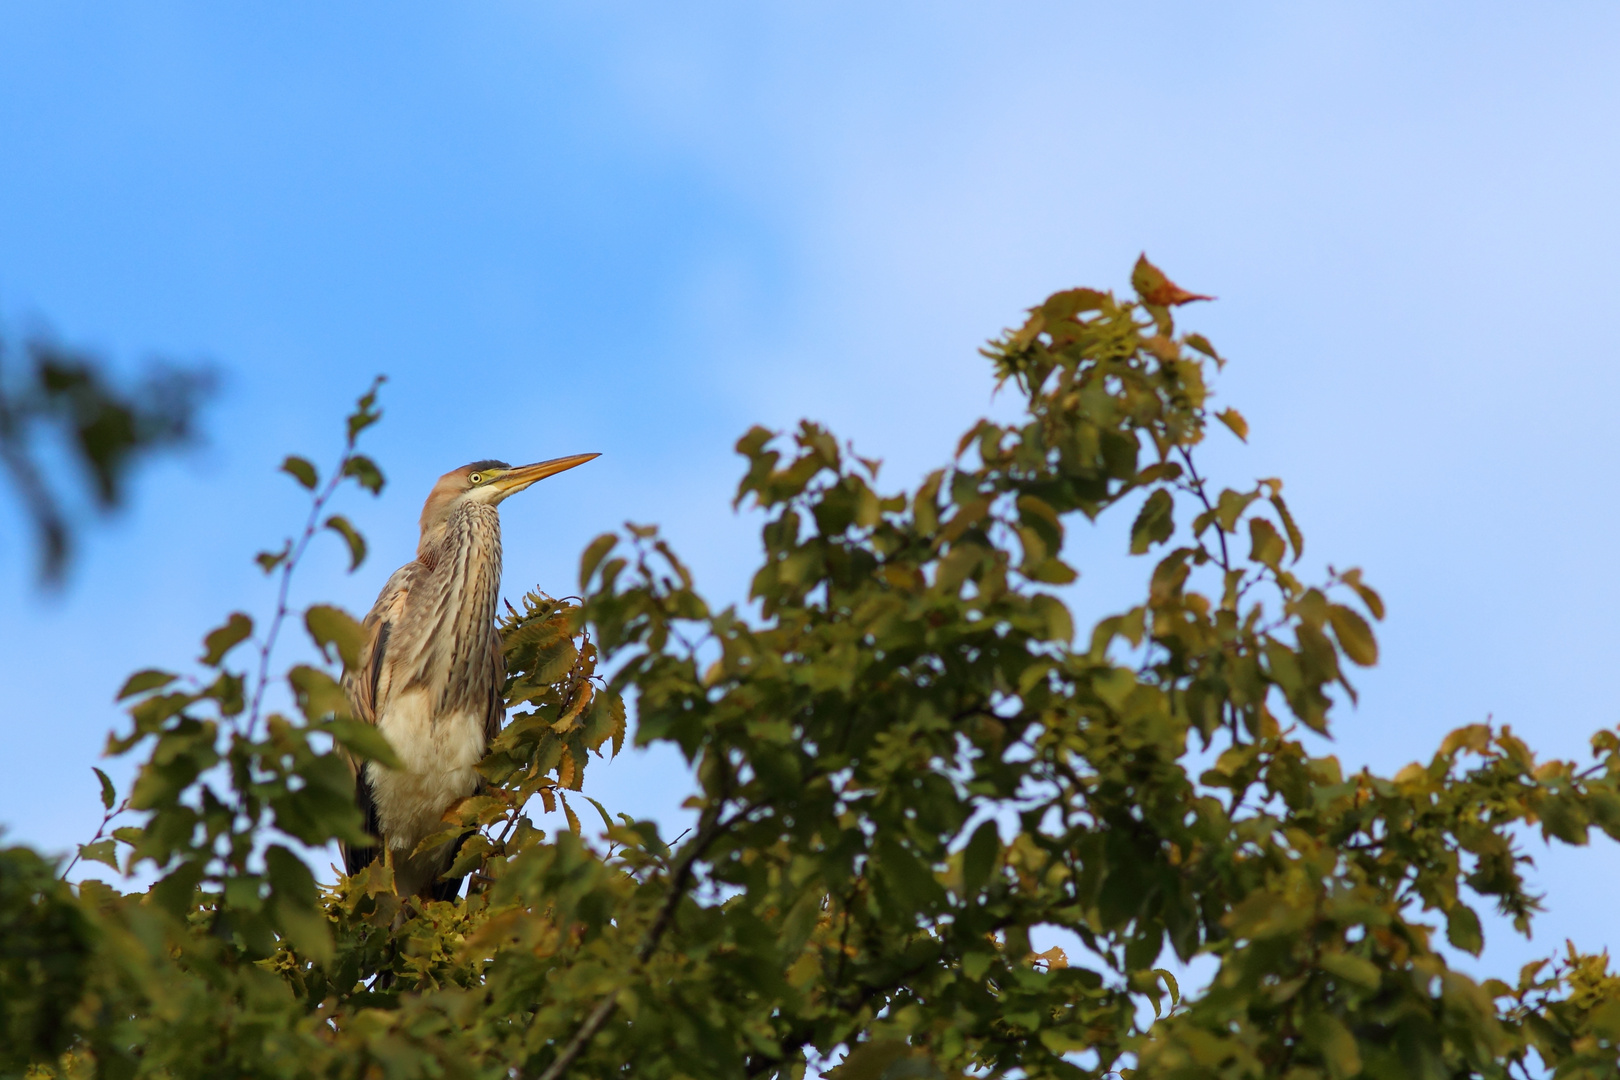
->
[[0, 259, 1620, 1080]]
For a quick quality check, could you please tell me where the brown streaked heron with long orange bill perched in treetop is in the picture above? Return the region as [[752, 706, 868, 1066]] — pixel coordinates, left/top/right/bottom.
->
[[343, 453, 601, 900]]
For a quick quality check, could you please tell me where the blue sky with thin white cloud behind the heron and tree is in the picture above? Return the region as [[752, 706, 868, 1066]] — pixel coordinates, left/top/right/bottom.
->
[[0, 0, 1620, 990]]
